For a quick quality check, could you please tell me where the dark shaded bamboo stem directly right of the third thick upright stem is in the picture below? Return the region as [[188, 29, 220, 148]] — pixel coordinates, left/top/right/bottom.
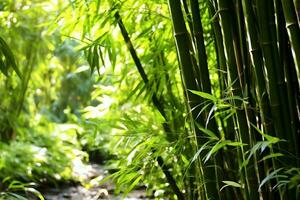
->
[[234, 0, 266, 198]]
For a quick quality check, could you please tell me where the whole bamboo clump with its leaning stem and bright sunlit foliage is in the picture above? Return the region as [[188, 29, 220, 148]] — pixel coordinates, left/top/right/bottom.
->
[[0, 0, 300, 200]]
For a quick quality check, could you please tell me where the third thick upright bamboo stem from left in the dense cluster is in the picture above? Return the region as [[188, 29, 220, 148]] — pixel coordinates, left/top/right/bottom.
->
[[218, 0, 258, 199]]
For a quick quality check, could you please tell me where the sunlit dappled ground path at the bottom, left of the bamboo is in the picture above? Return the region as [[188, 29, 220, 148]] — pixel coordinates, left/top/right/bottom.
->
[[42, 163, 151, 200]]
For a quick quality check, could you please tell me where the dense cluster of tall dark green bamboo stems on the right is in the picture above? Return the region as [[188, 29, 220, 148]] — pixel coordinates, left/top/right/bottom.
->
[[169, 0, 300, 199]]
